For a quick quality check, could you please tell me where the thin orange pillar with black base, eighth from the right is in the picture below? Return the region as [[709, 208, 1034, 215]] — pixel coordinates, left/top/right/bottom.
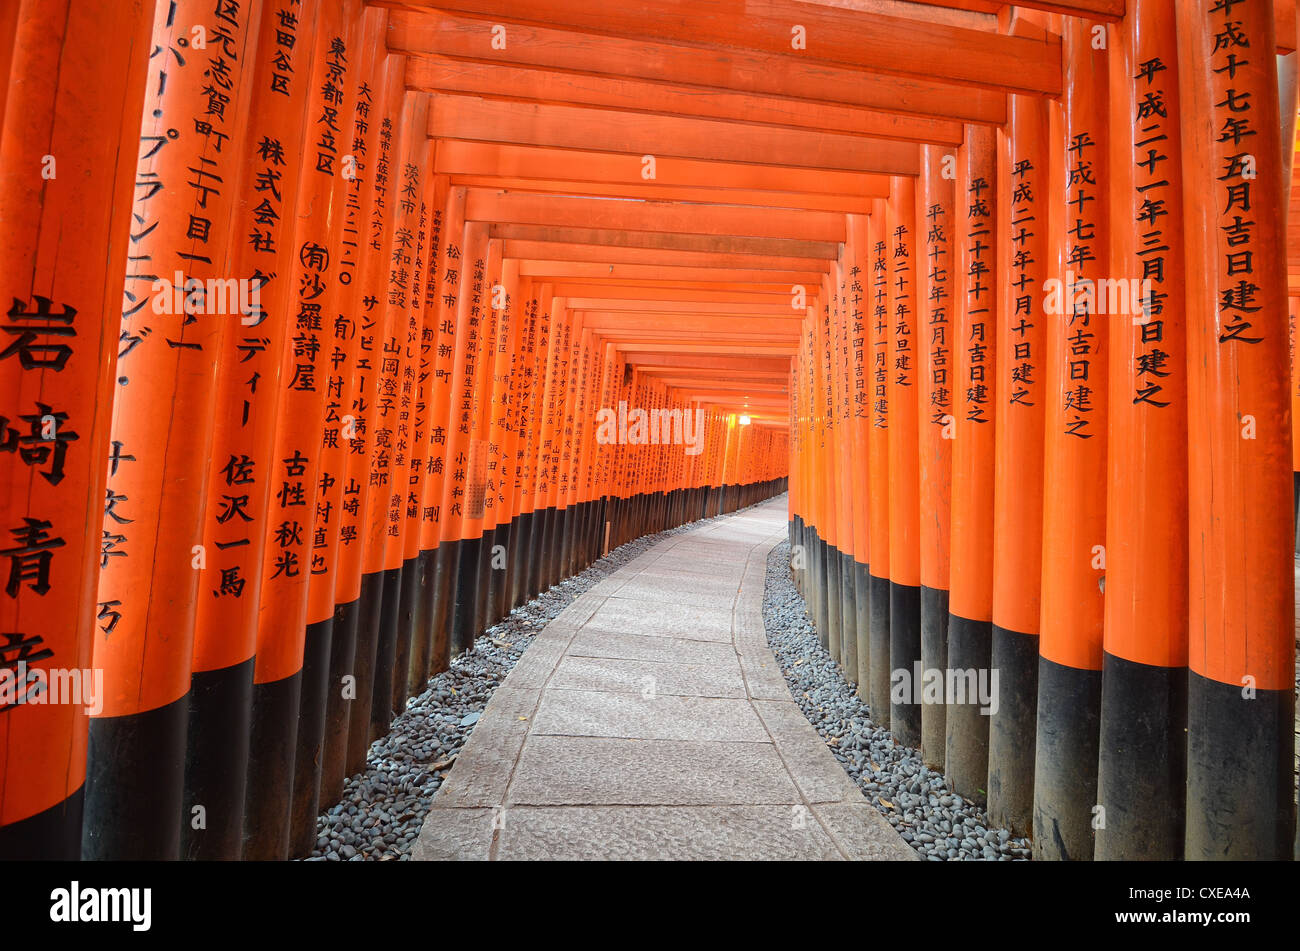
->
[[867, 199, 893, 729]]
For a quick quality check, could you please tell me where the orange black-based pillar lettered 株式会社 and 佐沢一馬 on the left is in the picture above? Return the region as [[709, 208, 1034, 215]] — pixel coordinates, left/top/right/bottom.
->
[[181, 0, 317, 859]]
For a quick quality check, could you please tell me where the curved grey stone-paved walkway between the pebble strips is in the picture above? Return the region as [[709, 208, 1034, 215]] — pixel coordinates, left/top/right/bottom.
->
[[412, 496, 917, 860]]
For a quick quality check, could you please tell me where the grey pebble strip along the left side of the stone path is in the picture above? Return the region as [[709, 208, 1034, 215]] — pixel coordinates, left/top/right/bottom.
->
[[306, 504, 759, 861]]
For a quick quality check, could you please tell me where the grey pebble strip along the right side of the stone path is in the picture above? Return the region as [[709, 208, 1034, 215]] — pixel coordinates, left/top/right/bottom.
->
[[763, 542, 1030, 861]]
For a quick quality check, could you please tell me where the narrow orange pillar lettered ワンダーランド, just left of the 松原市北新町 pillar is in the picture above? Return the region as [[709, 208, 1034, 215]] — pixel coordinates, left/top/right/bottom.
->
[[393, 152, 447, 716]]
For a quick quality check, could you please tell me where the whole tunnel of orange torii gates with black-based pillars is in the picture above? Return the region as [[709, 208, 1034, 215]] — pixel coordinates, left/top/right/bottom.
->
[[0, 0, 1300, 859]]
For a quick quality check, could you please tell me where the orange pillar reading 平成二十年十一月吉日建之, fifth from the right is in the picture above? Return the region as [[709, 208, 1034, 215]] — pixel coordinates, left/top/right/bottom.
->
[[944, 126, 1005, 803]]
